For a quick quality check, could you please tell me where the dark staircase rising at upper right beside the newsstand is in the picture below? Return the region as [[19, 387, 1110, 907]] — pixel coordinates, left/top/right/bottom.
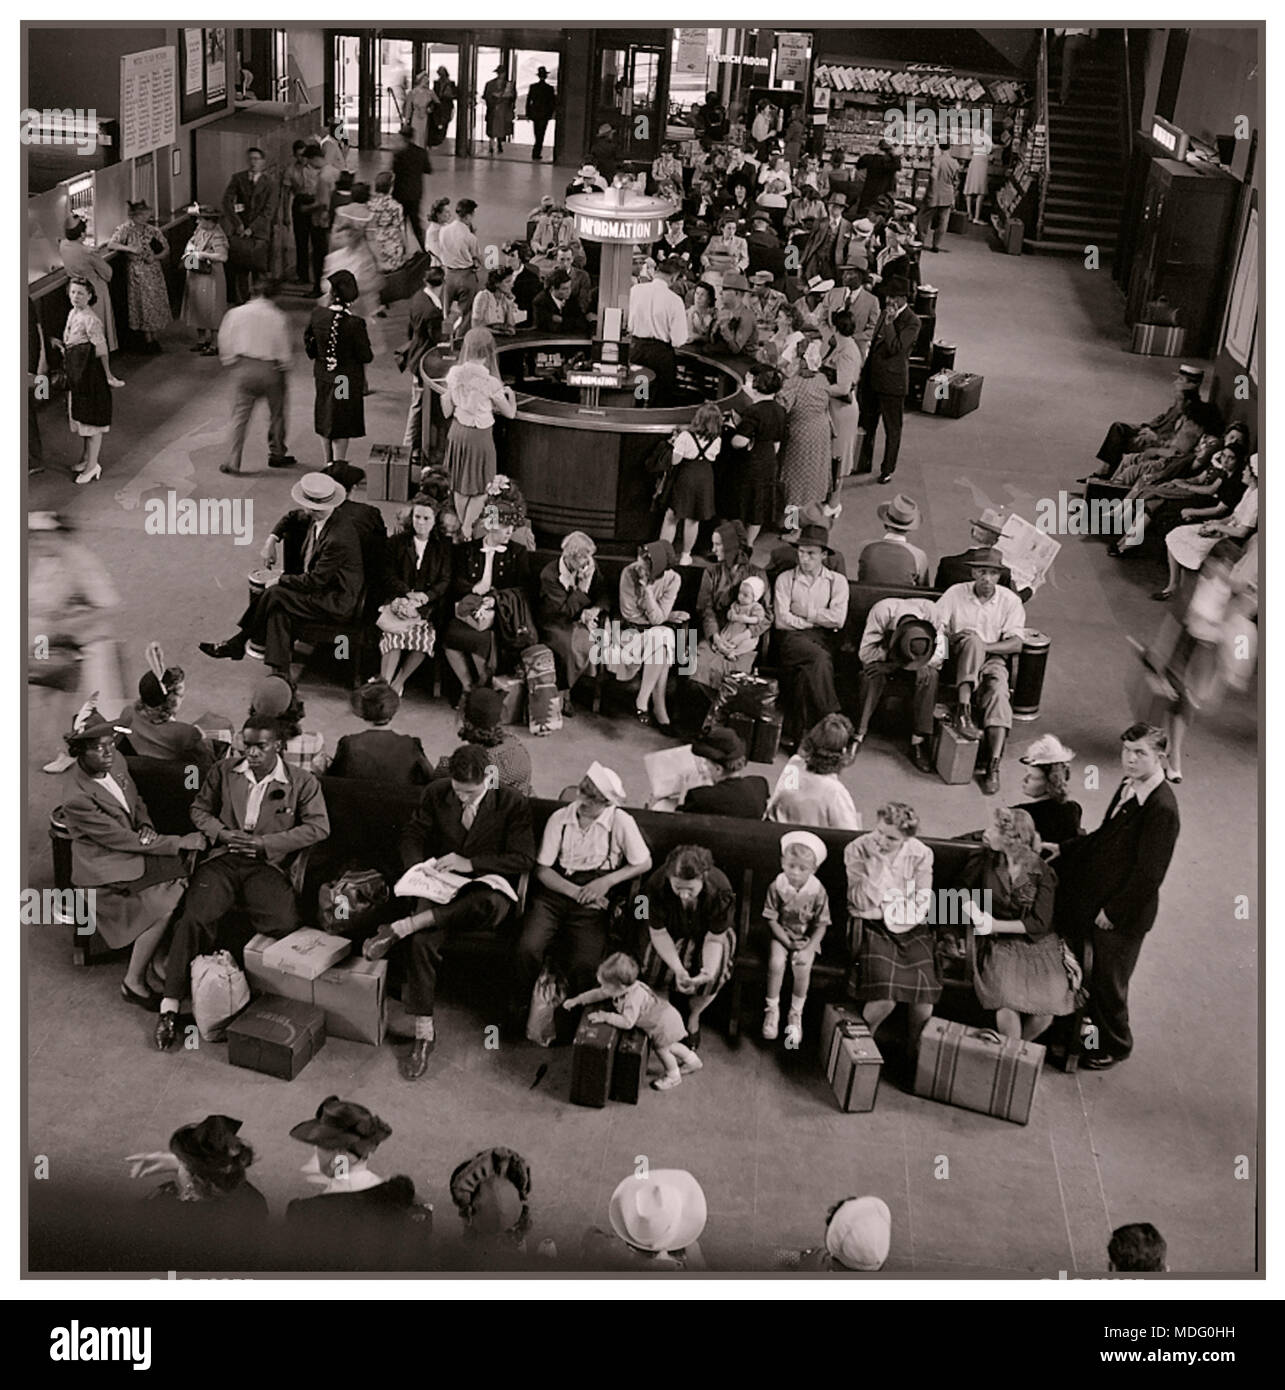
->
[[1026, 29, 1126, 263]]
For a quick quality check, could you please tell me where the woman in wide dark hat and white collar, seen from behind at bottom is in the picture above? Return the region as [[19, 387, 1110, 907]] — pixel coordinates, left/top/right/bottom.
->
[[285, 1095, 433, 1269]]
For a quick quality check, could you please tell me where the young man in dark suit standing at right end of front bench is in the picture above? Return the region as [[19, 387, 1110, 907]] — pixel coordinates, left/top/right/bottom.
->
[[1057, 724, 1181, 1072]]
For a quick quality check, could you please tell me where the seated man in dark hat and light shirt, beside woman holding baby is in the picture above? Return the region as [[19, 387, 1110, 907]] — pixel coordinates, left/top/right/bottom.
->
[[773, 525, 848, 752]]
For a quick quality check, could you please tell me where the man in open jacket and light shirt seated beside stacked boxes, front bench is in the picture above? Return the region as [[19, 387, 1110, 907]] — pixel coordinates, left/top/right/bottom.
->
[[154, 714, 330, 1052]]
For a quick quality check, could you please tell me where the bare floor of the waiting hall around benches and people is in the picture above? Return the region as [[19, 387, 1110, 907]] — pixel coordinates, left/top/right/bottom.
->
[[25, 149, 1259, 1277]]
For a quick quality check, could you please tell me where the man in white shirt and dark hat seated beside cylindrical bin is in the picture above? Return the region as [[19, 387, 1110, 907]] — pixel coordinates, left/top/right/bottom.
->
[[936, 549, 1026, 796]]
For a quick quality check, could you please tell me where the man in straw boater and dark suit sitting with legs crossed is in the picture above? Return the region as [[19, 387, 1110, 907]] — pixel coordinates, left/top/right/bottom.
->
[[199, 473, 366, 680]]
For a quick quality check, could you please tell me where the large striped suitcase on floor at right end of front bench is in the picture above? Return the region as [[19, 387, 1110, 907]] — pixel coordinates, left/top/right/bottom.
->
[[915, 1017, 1044, 1125]]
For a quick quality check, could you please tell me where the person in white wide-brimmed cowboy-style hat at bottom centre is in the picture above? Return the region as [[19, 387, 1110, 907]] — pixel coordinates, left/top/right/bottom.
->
[[580, 1168, 708, 1270]]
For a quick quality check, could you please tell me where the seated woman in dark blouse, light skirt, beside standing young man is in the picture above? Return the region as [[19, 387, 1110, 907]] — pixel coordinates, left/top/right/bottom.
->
[[958, 806, 1083, 1041]]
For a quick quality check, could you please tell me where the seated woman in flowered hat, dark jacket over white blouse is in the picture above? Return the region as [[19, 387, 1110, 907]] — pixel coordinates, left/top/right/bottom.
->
[[442, 505, 530, 692]]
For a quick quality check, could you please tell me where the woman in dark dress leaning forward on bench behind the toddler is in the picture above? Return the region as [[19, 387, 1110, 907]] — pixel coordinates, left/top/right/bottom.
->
[[638, 845, 736, 1049]]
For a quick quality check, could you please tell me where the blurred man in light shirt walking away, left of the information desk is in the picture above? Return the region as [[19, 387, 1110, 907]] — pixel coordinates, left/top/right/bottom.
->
[[218, 275, 295, 473]]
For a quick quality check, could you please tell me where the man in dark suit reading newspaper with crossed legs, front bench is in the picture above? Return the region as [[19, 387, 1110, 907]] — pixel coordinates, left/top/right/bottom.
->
[[362, 744, 535, 1081]]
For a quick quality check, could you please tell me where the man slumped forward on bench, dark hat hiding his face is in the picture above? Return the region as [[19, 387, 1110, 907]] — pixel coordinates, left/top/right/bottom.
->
[[855, 598, 947, 773]]
